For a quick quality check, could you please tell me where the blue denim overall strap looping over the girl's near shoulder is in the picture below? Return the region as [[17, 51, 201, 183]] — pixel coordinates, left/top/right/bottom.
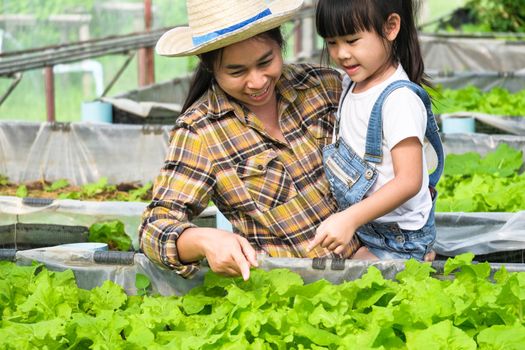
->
[[364, 80, 445, 187]]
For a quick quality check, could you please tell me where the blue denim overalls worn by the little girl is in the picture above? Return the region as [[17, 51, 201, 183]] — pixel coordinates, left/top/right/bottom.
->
[[323, 80, 444, 260]]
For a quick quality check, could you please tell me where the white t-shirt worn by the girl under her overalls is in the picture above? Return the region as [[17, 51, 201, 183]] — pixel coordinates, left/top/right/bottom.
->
[[339, 65, 432, 230]]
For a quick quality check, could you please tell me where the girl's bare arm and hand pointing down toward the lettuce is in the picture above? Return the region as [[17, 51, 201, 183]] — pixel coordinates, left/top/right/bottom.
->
[[309, 137, 423, 254]]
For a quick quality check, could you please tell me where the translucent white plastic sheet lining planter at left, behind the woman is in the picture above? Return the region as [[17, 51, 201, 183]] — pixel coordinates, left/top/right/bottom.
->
[[0, 122, 171, 185]]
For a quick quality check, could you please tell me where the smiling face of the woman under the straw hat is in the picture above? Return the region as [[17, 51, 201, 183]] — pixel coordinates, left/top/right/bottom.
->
[[214, 37, 283, 110]]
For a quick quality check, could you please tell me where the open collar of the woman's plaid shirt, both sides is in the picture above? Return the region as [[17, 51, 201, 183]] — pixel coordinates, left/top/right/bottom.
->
[[204, 65, 320, 124]]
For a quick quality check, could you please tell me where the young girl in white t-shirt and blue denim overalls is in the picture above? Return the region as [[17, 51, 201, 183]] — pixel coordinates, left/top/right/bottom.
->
[[309, 0, 443, 260]]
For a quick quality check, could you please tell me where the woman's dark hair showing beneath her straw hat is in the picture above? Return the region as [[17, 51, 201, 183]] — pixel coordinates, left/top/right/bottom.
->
[[181, 27, 285, 113]]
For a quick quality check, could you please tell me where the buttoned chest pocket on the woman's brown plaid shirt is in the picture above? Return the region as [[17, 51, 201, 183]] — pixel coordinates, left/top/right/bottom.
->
[[237, 149, 297, 211]]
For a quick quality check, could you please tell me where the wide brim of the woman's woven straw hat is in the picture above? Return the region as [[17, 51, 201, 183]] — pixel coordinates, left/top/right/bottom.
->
[[155, 0, 303, 57]]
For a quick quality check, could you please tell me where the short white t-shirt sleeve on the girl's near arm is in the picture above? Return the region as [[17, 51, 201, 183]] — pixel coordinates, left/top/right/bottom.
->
[[383, 88, 427, 150]]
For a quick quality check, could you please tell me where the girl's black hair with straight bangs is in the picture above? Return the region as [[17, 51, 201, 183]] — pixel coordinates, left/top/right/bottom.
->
[[315, 0, 431, 86]]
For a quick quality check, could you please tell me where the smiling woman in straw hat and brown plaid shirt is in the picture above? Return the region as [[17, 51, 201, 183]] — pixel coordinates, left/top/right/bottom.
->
[[140, 0, 359, 279]]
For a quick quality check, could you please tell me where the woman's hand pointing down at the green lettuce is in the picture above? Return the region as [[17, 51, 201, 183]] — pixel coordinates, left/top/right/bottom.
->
[[177, 228, 258, 280]]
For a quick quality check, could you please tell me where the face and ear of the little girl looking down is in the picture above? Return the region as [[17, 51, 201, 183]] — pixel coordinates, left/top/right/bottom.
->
[[325, 14, 400, 92]]
